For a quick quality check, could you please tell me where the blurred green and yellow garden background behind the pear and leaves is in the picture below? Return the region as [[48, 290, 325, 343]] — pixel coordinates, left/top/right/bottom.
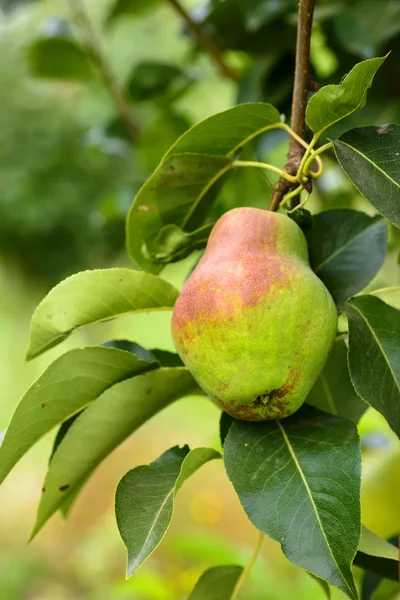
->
[[0, 0, 400, 600]]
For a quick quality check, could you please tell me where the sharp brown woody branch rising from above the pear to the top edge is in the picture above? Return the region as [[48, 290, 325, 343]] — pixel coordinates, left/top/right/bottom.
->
[[269, 0, 315, 211]]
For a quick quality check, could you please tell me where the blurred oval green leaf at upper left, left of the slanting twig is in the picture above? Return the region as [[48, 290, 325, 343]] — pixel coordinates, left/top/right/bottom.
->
[[27, 34, 93, 81]]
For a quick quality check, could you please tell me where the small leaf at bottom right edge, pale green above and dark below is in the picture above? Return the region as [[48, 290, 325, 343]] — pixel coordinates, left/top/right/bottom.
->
[[354, 525, 399, 581]]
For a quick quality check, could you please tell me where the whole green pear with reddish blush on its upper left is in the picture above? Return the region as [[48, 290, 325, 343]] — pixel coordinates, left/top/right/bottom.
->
[[172, 208, 337, 421]]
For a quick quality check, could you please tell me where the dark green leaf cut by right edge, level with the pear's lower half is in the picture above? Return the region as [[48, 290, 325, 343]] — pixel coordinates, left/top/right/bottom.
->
[[344, 296, 400, 437]]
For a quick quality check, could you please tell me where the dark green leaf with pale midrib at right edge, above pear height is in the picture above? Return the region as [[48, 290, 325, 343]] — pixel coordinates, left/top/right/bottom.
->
[[334, 125, 400, 229]]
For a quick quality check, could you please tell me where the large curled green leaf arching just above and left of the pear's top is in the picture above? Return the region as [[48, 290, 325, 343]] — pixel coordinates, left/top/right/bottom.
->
[[126, 102, 280, 273]]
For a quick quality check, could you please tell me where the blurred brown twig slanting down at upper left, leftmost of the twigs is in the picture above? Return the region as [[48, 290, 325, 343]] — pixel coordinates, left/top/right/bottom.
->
[[68, 0, 139, 140]]
